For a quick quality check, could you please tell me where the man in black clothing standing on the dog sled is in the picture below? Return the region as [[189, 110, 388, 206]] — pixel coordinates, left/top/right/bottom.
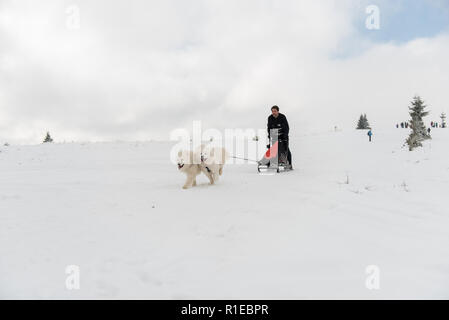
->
[[267, 106, 293, 169]]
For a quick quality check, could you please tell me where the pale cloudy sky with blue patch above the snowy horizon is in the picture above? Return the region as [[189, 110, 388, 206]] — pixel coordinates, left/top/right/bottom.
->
[[0, 0, 449, 143]]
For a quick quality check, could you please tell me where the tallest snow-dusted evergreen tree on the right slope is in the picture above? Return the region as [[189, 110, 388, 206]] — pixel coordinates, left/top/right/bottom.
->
[[405, 96, 431, 151]]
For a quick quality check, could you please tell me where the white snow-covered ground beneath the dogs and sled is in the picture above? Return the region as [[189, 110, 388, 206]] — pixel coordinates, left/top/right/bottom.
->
[[0, 129, 449, 299]]
